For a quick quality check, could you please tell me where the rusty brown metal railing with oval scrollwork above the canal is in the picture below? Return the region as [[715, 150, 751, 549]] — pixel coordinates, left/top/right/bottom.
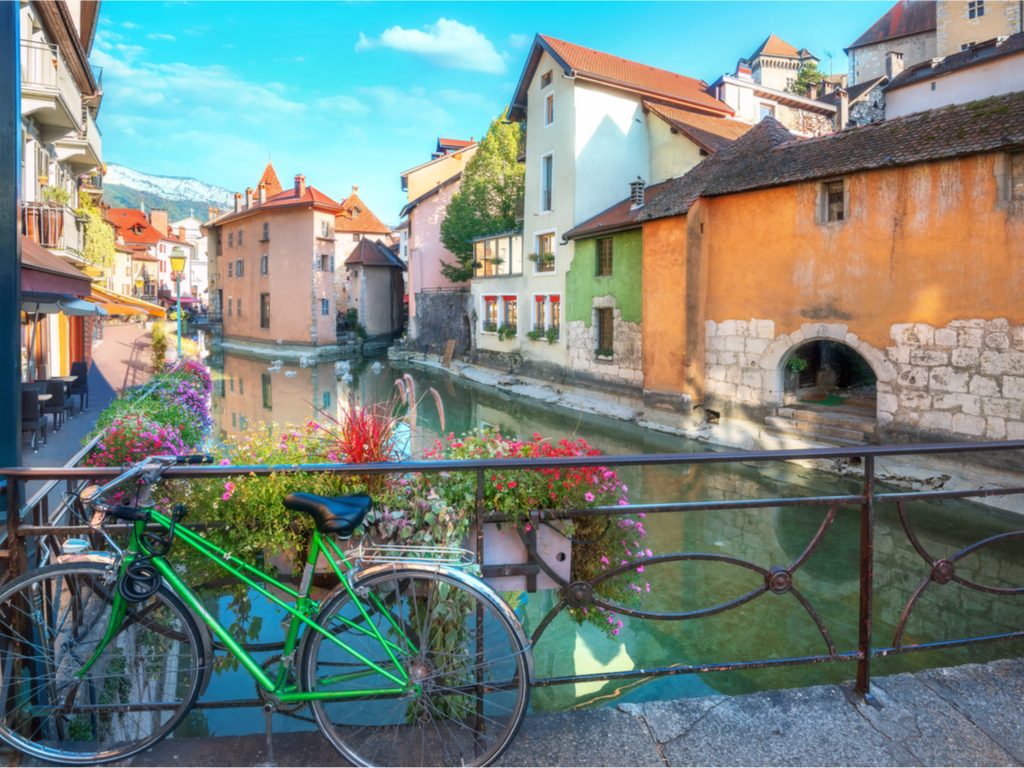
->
[[0, 440, 1024, 707]]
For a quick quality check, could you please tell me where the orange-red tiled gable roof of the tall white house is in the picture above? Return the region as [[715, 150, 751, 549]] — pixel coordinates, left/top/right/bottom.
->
[[509, 35, 734, 121]]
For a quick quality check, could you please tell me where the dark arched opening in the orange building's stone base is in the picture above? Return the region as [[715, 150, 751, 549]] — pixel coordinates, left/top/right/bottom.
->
[[782, 339, 878, 415]]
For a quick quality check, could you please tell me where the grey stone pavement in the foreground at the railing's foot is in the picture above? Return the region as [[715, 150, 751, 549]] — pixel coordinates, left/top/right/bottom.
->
[[22, 659, 1024, 767]]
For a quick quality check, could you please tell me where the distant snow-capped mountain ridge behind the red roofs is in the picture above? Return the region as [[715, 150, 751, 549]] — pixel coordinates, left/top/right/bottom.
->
[[103, 163, 234, 221]]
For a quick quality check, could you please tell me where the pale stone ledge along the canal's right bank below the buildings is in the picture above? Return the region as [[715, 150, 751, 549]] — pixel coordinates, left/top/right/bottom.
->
[[388, 348, 1024, 515]]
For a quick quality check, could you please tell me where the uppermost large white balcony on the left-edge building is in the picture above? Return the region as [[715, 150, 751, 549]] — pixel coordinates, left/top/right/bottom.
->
[[22, 40, 82, 142]]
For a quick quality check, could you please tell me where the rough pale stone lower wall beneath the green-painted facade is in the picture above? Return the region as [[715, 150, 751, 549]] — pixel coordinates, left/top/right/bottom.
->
[[565, 296, 643, 386]]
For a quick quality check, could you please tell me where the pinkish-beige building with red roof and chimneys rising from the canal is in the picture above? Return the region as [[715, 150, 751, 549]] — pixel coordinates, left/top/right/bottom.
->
[[204, 164, 342, 358]]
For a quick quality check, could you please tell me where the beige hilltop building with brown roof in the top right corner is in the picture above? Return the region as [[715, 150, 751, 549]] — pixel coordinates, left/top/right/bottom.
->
[[845, 0, 1022, 86]]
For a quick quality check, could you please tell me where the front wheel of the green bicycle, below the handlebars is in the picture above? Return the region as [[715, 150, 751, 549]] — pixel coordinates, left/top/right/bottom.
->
[[0, 562, 205, 765]]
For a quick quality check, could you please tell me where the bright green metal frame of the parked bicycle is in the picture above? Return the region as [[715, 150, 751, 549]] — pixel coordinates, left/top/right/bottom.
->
[[76, 510, 420, 702]]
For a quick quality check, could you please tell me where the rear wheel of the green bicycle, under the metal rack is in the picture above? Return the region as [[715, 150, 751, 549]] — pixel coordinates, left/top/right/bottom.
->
[[302, 566, 531, 766]]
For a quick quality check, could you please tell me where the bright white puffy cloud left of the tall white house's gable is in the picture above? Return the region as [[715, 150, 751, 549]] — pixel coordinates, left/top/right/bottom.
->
[[355, 18, 508, 75]]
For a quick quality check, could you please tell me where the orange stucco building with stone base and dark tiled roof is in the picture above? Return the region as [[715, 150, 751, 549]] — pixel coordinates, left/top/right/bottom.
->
[[640, 93, 1024, 448]]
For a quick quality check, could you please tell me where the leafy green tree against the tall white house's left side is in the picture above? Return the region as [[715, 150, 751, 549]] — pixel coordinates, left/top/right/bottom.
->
[[440, 109, 526, 283]]
